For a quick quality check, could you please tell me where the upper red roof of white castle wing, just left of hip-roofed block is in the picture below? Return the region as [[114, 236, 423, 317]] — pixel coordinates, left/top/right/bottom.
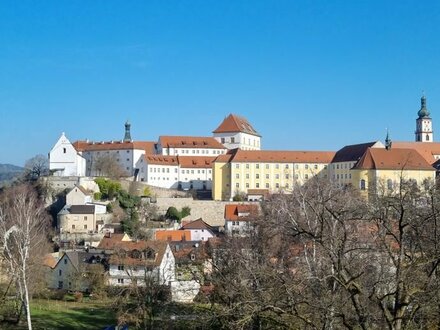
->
[[159, 135, 226, 149]]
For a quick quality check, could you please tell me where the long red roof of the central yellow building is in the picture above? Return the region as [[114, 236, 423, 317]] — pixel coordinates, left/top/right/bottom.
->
[[215, 149, 335, 164]]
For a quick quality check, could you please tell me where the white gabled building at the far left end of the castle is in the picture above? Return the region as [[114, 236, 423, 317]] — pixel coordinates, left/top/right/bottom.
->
[[49, 133, 86, 176]]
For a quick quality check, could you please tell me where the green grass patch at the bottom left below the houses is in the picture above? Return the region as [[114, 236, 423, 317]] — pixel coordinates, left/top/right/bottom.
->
[[7, 300, 115, 330]]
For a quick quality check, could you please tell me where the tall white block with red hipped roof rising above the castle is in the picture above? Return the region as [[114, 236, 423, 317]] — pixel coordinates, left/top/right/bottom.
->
[[213, 114, 261, 150]]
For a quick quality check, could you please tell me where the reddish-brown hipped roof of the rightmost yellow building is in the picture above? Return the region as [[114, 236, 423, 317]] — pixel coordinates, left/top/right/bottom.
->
[[353, 148, 435, 171]]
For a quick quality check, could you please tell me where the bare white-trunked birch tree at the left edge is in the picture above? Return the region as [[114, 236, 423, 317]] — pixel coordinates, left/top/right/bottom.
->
[[0, 185, 50, 329]]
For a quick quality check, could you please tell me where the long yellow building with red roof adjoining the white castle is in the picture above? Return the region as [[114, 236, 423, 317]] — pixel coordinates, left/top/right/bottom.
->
[[212, 149, 335, 200]]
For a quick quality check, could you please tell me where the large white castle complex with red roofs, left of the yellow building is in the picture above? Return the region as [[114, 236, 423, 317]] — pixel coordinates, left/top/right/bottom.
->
[[49, 114, 261, 190]]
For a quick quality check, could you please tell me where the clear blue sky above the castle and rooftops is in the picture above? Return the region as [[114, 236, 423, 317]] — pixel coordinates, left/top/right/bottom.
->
[[0, 0, 440, 165]]
